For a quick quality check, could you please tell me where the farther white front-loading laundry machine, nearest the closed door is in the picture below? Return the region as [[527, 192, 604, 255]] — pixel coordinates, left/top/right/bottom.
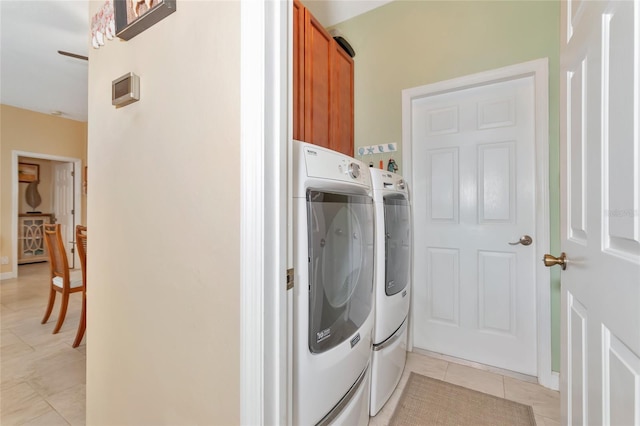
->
[[370, 168, 411, 416]]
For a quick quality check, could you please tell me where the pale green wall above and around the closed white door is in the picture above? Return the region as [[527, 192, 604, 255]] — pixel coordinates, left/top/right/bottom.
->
[[335, 0, 560, 371]]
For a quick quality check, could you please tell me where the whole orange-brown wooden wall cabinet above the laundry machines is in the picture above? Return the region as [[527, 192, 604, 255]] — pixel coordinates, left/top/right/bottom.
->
[[293, 0, 354, 157]]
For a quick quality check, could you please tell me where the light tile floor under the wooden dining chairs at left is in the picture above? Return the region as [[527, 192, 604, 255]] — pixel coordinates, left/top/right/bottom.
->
[[0, 263, 86, 426]]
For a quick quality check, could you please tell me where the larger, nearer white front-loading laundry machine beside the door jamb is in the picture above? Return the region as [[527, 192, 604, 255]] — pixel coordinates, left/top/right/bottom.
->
[[292, 141, 375, 426]]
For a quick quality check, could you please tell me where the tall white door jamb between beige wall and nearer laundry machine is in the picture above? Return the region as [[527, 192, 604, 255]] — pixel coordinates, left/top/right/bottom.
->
[[240, 0, 293, 425]]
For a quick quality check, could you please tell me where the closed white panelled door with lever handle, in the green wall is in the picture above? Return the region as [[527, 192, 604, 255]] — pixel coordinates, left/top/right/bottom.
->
[[411, 76, 537, 376]]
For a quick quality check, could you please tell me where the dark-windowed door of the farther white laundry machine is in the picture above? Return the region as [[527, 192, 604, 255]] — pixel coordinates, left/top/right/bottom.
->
[[384, 194, 411, 296]]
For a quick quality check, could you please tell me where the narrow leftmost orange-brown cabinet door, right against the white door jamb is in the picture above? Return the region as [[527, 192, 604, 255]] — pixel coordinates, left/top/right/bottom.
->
[[293, 0, 305, 140]]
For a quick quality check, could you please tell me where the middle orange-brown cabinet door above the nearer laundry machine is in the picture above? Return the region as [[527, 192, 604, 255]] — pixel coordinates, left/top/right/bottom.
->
[[304, 9, 335, 148]]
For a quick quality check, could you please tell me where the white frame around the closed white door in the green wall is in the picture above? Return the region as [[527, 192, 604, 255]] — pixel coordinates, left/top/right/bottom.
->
[[402, 58, 559, 390]]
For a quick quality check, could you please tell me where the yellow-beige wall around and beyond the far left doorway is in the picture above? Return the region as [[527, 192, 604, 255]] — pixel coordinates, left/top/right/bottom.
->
[[0, 105, 87, 274]]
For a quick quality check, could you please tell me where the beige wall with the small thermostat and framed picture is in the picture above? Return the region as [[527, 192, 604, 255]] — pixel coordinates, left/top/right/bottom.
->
[[87, 1, 241, 425]]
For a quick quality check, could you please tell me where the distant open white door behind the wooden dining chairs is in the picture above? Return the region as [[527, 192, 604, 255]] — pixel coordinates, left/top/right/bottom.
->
[[53, 163, 75, 268]]
